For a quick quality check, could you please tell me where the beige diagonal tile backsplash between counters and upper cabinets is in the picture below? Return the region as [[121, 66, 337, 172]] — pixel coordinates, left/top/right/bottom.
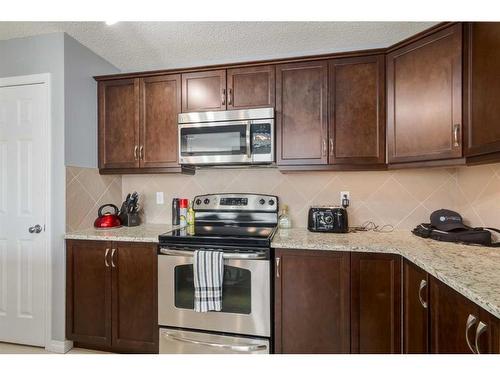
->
[[67, 164, 500, 229]]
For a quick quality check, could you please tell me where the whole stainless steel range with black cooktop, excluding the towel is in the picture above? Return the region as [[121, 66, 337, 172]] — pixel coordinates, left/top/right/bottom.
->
[[158, 194, 278, 353]]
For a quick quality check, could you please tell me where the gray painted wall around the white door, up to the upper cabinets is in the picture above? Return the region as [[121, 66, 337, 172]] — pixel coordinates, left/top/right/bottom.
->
[[0, 33, 118, 341]]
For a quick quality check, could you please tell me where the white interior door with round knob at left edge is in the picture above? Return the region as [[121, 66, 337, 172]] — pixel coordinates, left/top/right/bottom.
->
[[0, 80, 48, 346]]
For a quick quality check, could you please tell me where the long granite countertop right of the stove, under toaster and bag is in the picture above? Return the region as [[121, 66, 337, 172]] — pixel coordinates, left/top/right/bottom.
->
[[271, 228, 500, 319]]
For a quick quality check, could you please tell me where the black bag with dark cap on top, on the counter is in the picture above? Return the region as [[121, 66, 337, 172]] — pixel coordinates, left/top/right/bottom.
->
[[412, 209, 500, 247]]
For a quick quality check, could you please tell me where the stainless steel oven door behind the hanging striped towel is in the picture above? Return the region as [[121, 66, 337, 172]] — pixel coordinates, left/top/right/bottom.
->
[[158, 249, 271, 337]]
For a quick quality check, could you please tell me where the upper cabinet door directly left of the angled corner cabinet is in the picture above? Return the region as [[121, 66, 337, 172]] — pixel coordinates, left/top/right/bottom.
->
[[329, 55, 385, 165]]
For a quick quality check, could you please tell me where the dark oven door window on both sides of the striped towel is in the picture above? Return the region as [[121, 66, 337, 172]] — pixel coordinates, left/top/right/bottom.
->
[[174, 264, 252, 314]]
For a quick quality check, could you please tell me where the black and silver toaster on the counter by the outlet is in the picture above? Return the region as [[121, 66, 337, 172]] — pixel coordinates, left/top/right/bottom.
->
[[307, 206, 349, 233]]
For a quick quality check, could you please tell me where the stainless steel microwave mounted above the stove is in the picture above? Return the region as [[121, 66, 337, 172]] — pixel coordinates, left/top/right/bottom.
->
[[178, 108, 275, 165]]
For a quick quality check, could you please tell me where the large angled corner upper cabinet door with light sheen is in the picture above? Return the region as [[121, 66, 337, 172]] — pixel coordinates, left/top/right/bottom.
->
[[387, 24, 462, 163]]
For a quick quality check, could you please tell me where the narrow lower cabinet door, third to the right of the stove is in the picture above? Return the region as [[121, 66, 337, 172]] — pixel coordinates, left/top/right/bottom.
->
[[403, 260, 429, 354]]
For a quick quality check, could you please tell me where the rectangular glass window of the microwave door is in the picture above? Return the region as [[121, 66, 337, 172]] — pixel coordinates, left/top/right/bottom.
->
[[181, 125, 246, 156]]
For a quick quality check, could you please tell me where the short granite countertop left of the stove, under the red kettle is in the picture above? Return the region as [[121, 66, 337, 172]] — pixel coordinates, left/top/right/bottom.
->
[[64, 224, 178, 243]]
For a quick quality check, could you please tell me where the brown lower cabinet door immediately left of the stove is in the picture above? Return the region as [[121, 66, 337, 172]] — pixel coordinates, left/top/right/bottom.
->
[[111, 242, 158, 353]]
